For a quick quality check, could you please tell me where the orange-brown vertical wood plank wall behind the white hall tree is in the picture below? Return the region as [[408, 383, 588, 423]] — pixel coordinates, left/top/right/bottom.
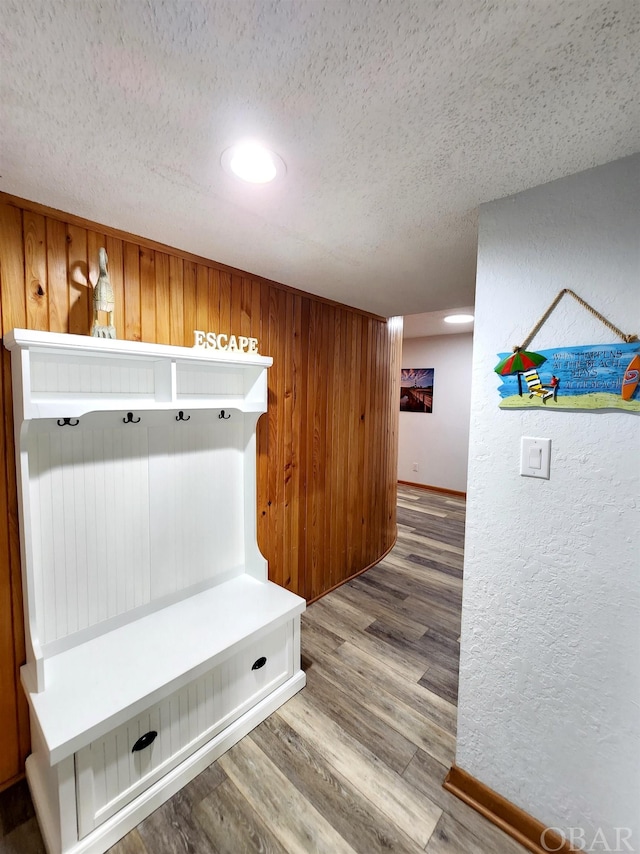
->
[[0, 194, 402, 788]]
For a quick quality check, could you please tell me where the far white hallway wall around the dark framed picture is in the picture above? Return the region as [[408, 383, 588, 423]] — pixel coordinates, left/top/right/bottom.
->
[[398, 333, 473, 492]]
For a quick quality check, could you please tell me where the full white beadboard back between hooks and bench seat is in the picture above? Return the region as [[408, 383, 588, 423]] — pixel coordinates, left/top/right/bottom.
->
[[28, 411, 245, 644]]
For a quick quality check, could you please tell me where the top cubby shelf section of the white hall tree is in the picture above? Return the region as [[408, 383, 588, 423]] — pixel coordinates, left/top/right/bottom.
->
[[4, 329, 273, 420]]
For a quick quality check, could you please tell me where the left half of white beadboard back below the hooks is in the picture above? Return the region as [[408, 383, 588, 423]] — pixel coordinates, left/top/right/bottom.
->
[[29, 421, 150, 643]]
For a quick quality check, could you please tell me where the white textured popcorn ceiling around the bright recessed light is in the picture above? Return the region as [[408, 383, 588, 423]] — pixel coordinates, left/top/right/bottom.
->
[[0, 0, 640, 315]]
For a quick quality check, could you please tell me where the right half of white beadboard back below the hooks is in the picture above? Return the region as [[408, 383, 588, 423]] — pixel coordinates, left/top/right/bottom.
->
[[149, 412, 245, 599]]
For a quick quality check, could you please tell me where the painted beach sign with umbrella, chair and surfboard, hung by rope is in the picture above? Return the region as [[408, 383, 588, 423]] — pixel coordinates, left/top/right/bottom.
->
[[494, 342, 640, 412]]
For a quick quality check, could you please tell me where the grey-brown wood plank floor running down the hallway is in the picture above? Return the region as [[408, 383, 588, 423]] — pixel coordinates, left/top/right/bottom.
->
[[0, 486, 524, 854]]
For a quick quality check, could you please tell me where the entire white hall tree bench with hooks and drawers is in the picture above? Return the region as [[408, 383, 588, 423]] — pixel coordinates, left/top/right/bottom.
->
[[4, 330, 305, 854]]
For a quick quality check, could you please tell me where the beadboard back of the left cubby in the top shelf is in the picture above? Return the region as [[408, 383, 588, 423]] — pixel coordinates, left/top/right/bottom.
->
[[31, 352, 154, 396]]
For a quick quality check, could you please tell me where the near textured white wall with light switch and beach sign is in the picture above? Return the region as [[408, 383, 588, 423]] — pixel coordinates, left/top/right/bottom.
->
[[456, 155, 640, 851]]
